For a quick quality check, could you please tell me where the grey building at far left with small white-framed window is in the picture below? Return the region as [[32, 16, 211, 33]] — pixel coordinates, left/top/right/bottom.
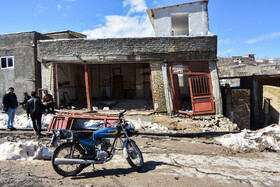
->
[[0, 31, 86, 111]]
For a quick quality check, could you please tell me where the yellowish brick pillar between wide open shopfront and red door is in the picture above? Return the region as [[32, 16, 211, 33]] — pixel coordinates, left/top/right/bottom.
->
[[150, 62, 166, 112]]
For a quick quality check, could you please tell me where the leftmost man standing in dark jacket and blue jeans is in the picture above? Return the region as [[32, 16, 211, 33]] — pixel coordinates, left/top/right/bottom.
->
[[2, 87, 18, 131]]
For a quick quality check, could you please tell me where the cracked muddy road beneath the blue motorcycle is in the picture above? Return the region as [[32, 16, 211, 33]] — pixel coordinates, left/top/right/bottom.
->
[[0, 132, 280, 187]]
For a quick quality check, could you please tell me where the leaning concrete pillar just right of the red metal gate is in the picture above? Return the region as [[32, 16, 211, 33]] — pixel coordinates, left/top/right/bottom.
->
[[209, 61, 223, 114]]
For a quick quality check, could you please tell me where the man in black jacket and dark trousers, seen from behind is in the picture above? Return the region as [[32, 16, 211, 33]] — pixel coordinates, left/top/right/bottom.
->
[[27, 91, 44, 138]]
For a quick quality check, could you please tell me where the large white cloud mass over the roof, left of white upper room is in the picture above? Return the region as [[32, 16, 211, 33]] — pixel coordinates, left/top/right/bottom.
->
[[83, 0, 154, 38]]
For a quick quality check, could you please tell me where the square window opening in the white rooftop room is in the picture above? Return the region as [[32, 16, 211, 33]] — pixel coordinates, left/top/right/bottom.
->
[[171, 13, 189, 36]]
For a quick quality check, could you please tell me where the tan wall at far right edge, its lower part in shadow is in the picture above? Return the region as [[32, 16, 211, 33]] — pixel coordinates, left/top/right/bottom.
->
[[263, 85, 280, 125]]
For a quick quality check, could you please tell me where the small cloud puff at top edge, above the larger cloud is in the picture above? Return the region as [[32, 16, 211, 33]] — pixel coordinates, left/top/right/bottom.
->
[[123, 0, 147, 15]]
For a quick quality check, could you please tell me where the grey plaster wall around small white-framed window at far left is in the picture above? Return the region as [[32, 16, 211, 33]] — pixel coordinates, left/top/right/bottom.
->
[[0, 32, 36, 112]]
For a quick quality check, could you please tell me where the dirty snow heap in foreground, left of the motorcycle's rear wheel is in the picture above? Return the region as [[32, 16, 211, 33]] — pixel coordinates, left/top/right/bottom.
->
[[0, 141, 52, 160]]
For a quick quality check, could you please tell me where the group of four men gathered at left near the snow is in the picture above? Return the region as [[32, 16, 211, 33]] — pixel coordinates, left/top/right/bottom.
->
[[2, 87, 55, 137]]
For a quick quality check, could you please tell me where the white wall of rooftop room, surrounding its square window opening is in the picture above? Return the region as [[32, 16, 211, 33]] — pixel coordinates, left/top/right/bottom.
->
[[153, 2, 209, 36]]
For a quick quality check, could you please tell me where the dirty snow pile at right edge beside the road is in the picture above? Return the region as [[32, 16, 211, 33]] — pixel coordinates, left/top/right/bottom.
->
[[216, 125, 280, 152]]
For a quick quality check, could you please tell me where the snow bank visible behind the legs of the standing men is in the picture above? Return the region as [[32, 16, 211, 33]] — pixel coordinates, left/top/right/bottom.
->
[[0, 113, 53, 128]]
